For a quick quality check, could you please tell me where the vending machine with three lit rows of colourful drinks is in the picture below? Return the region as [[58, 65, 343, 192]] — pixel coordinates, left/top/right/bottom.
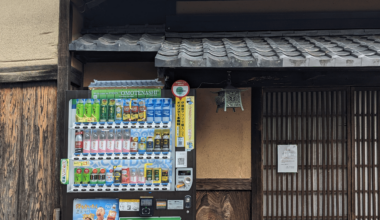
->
[[60, 90, 196, 220]]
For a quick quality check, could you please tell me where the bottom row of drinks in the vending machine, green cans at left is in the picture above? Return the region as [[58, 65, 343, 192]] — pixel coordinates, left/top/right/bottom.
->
[[74, 166, 169, 187]]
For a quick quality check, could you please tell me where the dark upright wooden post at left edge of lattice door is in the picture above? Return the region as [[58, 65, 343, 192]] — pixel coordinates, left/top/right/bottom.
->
[[251, 87, 264, 220]]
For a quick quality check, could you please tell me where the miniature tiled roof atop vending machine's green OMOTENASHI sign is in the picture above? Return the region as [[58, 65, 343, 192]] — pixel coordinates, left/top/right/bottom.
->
[[88, 79, 164, 88]]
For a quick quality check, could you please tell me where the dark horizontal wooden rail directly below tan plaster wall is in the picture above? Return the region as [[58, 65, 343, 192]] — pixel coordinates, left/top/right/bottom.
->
[[196, 179, 251, 190]]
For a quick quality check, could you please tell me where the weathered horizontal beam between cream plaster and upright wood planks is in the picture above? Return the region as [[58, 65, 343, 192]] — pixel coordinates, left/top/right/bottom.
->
[[0, 65, 57, 83]]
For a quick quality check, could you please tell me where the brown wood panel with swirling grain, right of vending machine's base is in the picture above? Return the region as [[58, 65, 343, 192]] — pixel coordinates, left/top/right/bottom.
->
[[196, 191, 251, 220]]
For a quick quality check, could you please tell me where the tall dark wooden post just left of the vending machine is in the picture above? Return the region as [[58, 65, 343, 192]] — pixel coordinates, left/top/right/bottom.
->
[[54, 0, 72, 215]]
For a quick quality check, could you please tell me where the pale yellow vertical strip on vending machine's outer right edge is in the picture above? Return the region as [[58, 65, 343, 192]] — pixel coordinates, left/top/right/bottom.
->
[[185, 96, 195, 150]]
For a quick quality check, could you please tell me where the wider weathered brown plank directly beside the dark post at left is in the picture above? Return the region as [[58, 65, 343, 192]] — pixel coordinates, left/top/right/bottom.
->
[[18, 82, 58, 220]]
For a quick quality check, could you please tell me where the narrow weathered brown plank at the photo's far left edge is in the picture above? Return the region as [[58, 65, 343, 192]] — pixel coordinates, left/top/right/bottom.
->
[[0, 83, 23, 220]]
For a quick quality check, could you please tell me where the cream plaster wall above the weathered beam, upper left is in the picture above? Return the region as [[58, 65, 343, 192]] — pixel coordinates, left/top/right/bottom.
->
[[0, 0, 59, 68]]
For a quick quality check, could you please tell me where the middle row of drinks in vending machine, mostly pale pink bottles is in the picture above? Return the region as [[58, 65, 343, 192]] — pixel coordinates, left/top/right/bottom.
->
[[74, 129, 170, 156]]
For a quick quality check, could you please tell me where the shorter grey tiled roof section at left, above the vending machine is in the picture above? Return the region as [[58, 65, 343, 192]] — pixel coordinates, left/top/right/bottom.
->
[[69, 34, 164, 52]]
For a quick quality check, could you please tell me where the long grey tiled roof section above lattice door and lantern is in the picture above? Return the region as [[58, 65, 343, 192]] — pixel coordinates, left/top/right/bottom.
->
[[155, 35, 380, 68]]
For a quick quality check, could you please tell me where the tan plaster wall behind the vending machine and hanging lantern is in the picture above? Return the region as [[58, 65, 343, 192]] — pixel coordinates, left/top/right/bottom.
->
[[83, 63, 251, 178]]
